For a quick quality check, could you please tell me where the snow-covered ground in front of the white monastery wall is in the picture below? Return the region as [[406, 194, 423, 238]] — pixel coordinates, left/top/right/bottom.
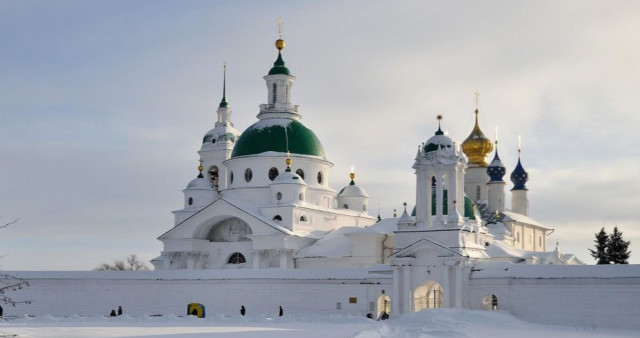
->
[[0, 309, 640, 338]]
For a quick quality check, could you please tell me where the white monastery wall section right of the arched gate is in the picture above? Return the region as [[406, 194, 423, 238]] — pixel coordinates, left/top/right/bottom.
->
[[466, 265, 640, 329]]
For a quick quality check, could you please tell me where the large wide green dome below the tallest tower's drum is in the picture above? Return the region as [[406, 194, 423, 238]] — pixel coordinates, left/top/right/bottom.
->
[[231, 118, 325, 158]]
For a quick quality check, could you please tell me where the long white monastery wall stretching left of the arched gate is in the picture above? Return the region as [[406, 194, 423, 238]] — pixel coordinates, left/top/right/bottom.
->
[[4, 269, 392, 317]]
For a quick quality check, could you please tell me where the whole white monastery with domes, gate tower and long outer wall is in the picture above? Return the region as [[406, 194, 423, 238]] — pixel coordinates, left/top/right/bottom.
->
[[6, 29, 640, 328]]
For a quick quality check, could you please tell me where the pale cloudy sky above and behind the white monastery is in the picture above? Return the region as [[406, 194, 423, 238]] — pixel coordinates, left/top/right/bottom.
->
[[0, 0, 640, 270]]
